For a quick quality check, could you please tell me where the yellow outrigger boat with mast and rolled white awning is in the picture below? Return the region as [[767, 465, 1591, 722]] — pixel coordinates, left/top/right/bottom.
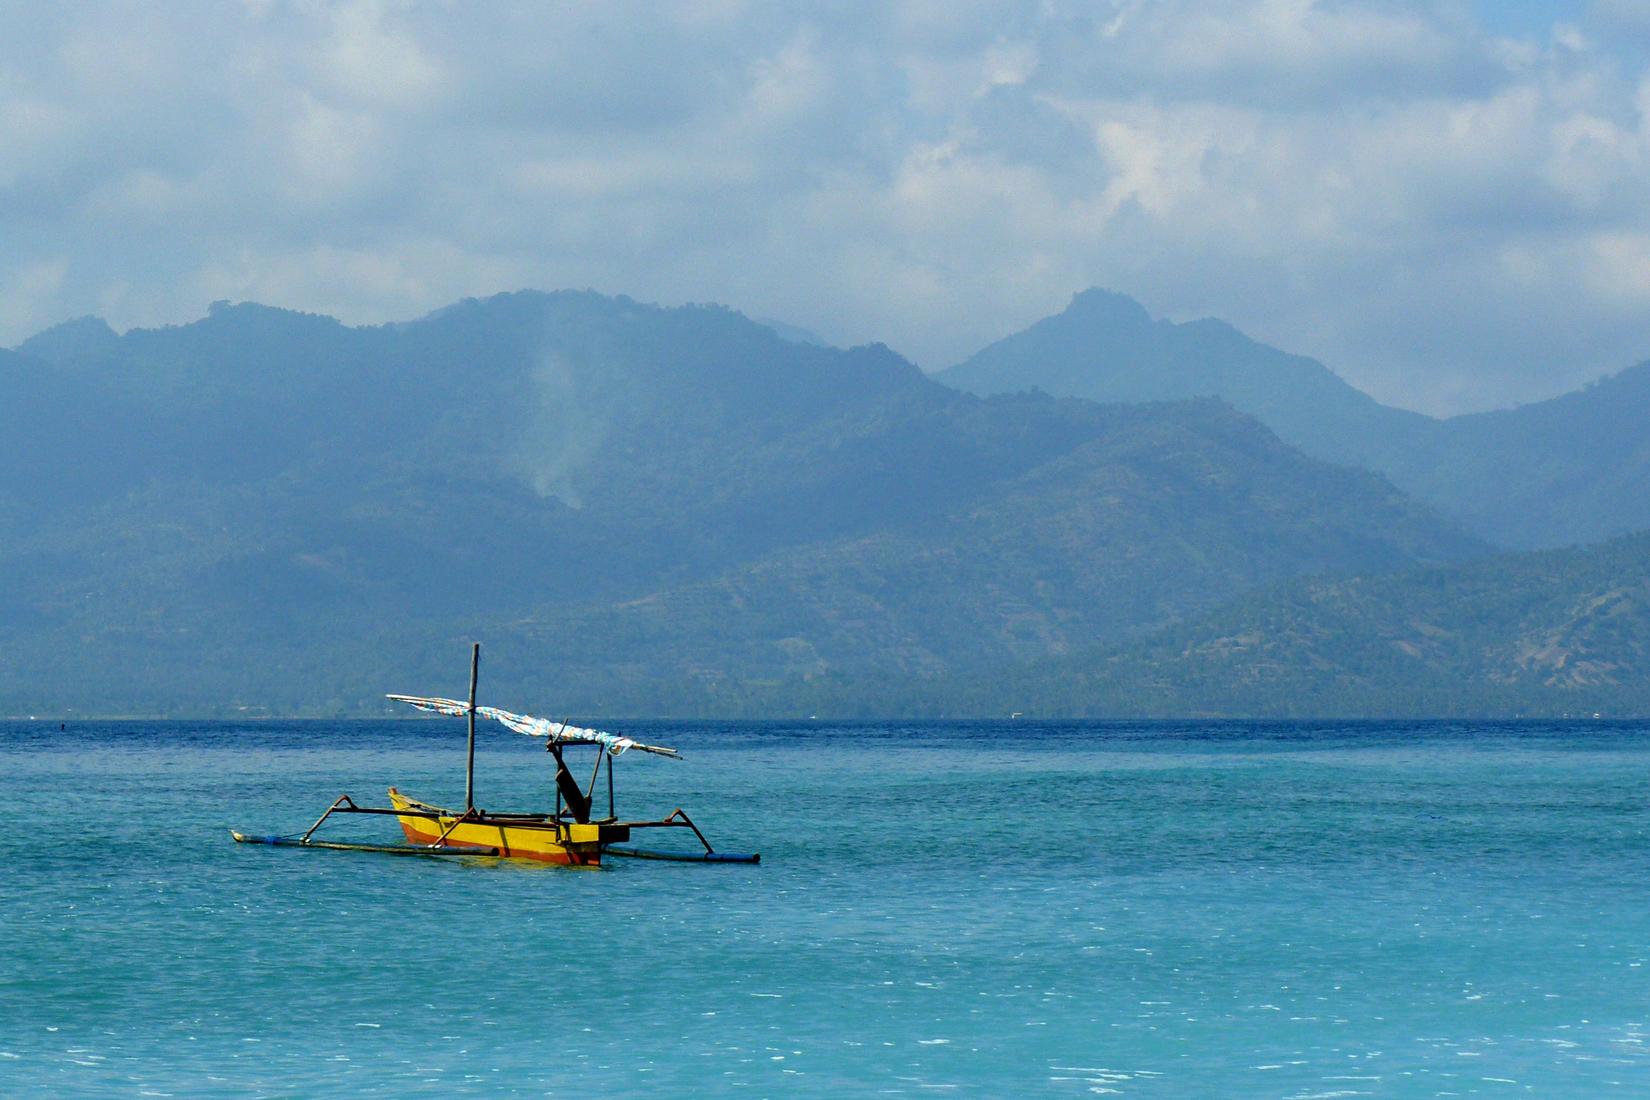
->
[[231, 643, 762, 867]]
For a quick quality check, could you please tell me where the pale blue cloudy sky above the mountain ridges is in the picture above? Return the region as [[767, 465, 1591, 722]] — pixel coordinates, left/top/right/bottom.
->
[[0, 0, 1650, 414]]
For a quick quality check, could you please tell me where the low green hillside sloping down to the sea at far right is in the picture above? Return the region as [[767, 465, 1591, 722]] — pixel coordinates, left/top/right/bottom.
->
[[950, 533, 1650, 717]]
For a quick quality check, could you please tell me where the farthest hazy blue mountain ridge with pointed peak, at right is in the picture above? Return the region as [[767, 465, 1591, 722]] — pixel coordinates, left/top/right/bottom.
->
[[939, 290, 1650, 549]]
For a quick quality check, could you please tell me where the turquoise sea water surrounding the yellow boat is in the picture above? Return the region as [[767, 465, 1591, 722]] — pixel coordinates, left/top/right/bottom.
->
[[0, 721, 1650, 1097]]
